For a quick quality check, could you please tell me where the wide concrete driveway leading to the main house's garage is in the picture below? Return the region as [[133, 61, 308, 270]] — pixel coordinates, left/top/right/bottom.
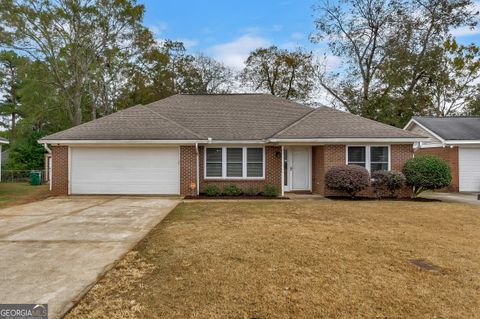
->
[[0, 197, 179, 318]]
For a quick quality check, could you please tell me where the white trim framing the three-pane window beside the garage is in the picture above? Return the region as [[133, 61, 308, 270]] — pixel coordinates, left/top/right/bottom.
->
[[203, 145, 266, 180]]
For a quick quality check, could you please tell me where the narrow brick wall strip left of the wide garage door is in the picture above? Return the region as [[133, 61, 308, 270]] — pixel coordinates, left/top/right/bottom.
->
[[51, 146, 68, 195]]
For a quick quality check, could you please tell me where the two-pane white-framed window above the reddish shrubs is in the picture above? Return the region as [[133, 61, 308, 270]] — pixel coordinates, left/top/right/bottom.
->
[[347, 146, 390, 173]]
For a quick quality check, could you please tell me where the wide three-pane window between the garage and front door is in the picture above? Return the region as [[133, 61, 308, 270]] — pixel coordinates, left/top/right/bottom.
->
[[205, 147, 264, 179]]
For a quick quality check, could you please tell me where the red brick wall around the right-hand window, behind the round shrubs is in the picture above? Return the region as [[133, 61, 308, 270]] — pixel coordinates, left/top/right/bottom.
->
[[312, 144, 413, 197]]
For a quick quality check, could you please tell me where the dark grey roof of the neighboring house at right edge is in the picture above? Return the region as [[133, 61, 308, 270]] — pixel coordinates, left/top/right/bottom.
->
[[406, 116, 480, 141]]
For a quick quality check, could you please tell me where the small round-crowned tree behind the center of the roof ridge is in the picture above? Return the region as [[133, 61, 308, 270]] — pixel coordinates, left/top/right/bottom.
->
[[241, 46, 315, 101]]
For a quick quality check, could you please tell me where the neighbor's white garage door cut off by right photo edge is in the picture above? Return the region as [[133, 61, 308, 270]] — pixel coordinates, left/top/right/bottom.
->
[[458, 148, 480, 192]]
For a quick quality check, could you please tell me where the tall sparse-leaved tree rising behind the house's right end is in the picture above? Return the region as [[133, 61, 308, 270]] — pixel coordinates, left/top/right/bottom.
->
[[312, 0, 477, 126]]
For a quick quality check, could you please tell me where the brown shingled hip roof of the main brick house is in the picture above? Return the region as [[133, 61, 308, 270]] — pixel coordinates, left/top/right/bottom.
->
[[40, 94, 421, 142]]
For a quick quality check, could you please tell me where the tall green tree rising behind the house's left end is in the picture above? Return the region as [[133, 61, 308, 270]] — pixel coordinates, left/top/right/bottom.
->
[[0, 0, 144, 125]]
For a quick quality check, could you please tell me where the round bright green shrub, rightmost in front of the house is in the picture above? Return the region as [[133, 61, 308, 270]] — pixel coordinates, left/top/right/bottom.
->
[[403, 155, 452, 196]]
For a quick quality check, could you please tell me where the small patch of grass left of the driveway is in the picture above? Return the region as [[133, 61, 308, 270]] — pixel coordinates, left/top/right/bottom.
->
[[0, 182, 50, 208]]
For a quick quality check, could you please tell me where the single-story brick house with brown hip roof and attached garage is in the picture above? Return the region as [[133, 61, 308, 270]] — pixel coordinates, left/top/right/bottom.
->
[[39, 94, 424, 195]]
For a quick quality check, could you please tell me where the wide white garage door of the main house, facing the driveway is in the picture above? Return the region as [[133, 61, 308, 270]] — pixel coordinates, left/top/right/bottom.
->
[[70, 147, 180, 194]]
